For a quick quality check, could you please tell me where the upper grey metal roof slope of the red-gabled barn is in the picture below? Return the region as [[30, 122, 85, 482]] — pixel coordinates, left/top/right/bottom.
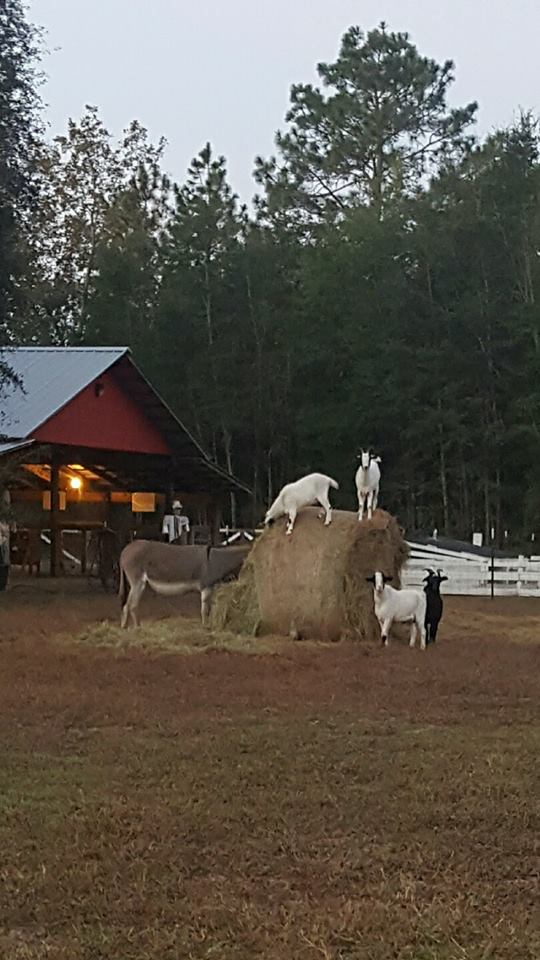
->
[[0, 347, 129, 440]]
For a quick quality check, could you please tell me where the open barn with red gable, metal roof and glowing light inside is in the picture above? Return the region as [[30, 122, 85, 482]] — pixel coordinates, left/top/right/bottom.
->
[[0, 347, 250, 576]]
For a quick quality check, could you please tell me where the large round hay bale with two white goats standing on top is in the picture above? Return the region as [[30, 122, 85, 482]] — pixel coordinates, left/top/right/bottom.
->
[[209, 507, 407, 641]]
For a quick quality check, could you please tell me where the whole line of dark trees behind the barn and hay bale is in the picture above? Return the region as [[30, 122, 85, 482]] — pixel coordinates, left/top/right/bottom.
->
[[0, 0, 540, 543]]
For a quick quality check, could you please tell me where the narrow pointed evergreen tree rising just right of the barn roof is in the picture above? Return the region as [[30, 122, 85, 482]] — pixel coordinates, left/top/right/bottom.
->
[[157, 144, 242, 466]]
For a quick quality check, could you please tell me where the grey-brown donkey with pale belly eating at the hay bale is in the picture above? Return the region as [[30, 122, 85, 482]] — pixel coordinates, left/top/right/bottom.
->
[[118, 540, 251, 627]]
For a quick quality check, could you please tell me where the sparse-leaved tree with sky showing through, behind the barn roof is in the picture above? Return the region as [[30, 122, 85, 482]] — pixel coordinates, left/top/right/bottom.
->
[[18, 106, 164, 344]]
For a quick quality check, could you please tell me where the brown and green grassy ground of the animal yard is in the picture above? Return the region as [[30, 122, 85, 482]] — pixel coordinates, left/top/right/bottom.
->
[[0, 577, 540, 960]]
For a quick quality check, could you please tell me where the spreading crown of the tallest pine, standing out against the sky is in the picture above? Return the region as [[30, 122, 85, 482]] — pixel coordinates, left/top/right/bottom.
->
[[256, 24, 476, 223]]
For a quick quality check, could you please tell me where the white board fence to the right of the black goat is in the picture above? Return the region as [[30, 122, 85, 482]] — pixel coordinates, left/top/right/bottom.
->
[[402, 543, 540, 597]]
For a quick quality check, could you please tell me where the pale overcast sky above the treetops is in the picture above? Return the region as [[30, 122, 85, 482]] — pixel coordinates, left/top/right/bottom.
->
[[29, 0, 540, 200]]
